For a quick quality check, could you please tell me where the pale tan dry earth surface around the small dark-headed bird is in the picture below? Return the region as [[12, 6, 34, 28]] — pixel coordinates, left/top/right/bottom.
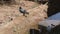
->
[[0, 1, 48, 34]]
